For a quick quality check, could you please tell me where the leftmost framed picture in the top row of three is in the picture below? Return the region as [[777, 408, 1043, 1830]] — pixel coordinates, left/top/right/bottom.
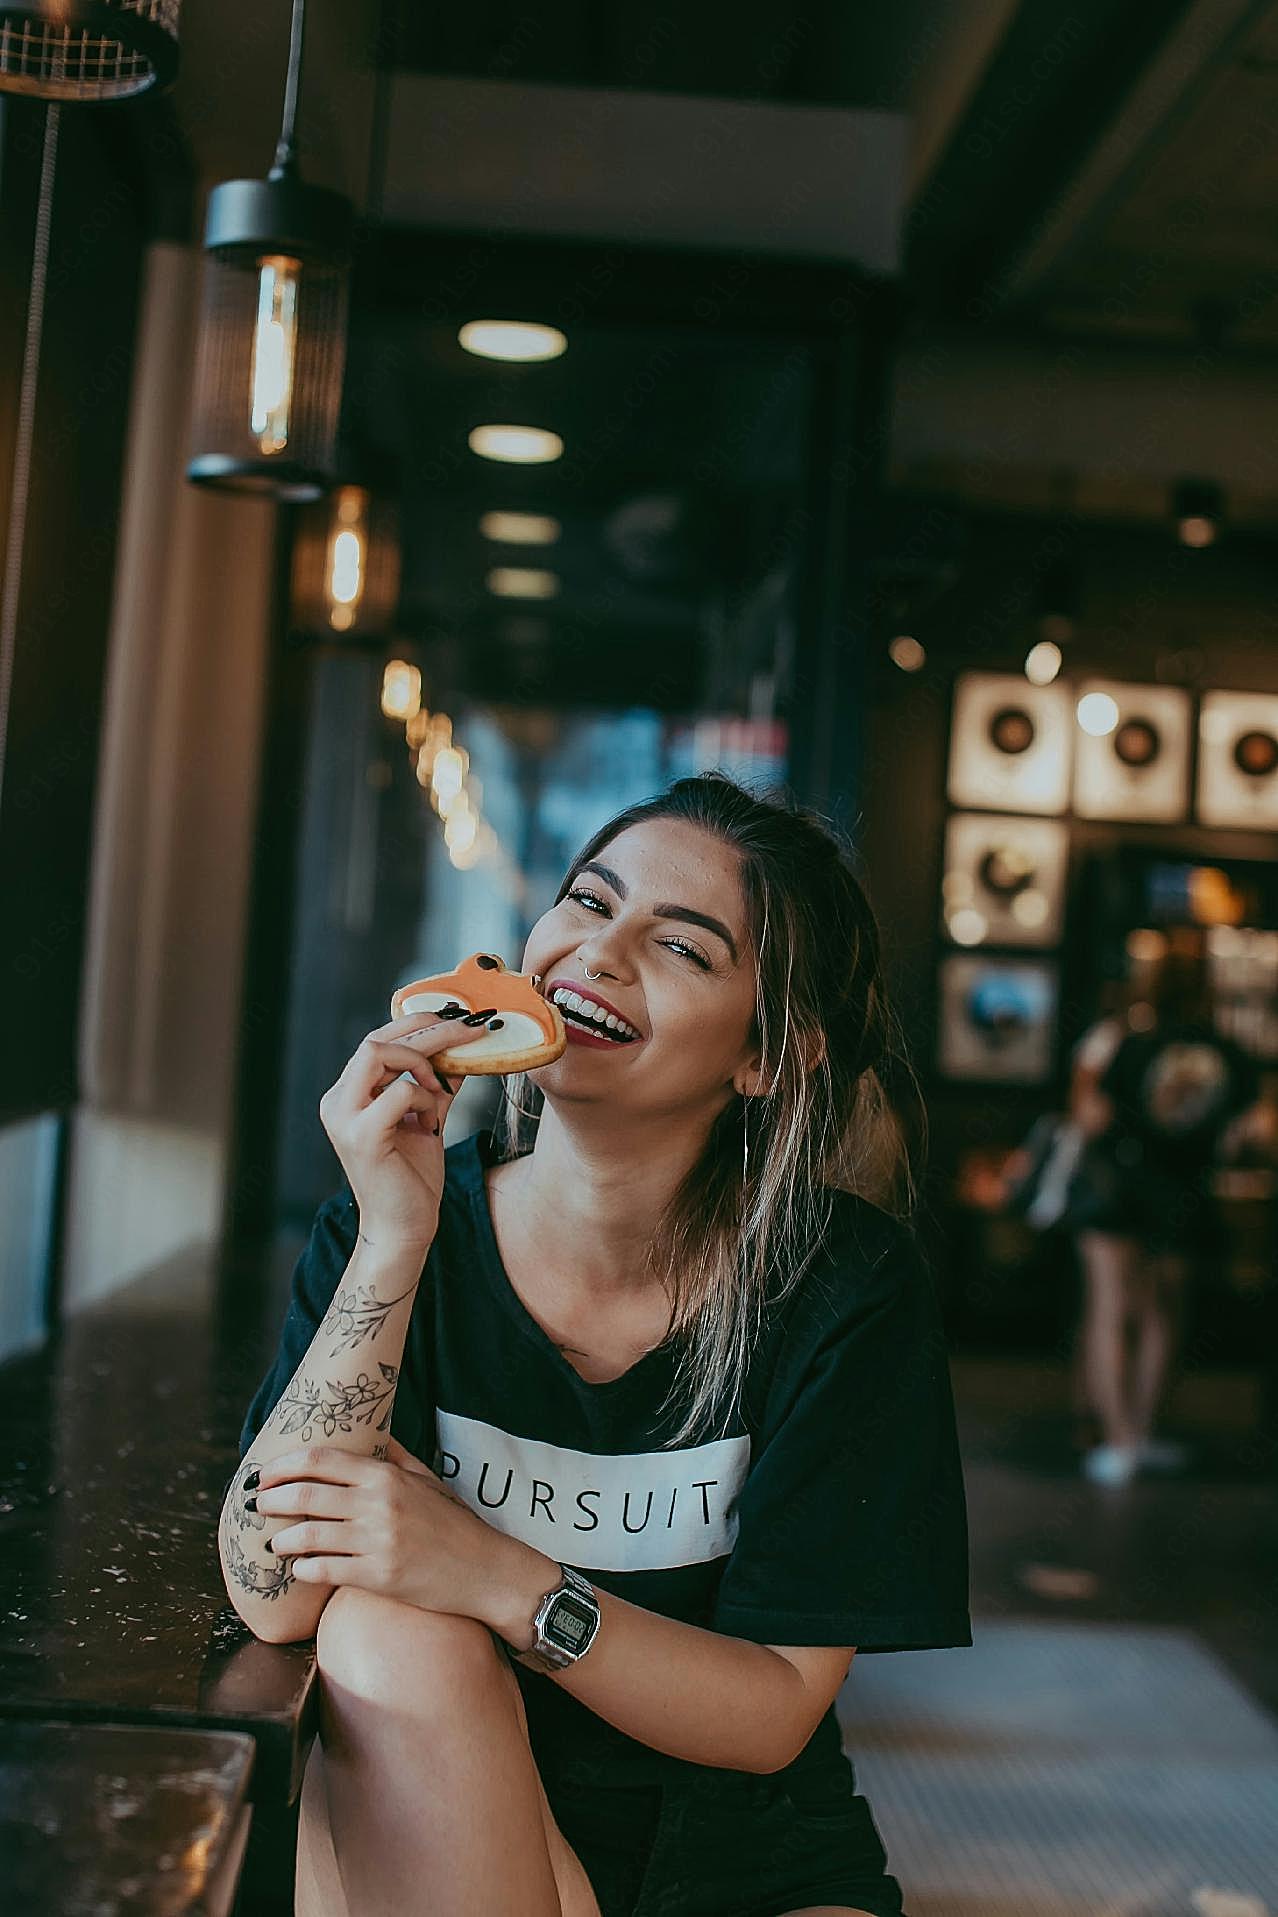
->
[[947, 673, 1073, 813]]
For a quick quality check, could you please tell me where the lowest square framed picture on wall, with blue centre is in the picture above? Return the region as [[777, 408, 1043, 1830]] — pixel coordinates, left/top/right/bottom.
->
[[937, 953, 1060, 1085]]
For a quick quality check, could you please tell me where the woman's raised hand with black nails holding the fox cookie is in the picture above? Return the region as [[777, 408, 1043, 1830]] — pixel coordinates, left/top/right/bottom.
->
[[320, 1012, 485, 1258]]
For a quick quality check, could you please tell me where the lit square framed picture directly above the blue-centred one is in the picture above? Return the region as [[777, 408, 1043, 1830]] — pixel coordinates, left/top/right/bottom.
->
[[941, 813, 1069, 945]]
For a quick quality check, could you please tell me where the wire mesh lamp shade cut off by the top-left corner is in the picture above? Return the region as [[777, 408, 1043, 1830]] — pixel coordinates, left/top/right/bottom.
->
[[0, 0, 182, 102]]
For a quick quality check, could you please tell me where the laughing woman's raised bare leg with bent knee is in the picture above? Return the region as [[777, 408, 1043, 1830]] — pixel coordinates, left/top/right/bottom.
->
[[295, 1587, 598, 1917]]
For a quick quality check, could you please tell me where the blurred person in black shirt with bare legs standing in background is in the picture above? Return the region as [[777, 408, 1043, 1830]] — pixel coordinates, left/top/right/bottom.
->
[[1071, 939, 1267, 1484]]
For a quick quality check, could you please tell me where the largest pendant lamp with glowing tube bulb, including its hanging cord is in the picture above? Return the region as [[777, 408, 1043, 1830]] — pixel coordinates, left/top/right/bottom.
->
[[186, 0, 353, 500]]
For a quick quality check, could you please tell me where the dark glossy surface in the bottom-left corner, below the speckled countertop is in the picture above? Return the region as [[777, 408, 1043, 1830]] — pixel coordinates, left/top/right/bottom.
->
[[0, 1721, 253, 1917]]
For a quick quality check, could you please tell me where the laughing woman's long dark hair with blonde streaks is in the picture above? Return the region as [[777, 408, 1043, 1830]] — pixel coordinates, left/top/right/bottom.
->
[[494, 771, 922, 1445]]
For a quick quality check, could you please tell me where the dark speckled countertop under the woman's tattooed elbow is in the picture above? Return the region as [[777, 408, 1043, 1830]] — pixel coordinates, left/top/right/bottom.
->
[[0, 1246, 314, 1802]]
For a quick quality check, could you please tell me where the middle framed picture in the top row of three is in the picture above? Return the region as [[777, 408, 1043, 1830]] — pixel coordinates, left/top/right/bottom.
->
[[1073, 679, 1190, 820]]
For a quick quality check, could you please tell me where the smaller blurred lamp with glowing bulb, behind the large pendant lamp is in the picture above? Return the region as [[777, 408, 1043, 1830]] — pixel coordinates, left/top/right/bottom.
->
[[293, 485, 399, 642]]
